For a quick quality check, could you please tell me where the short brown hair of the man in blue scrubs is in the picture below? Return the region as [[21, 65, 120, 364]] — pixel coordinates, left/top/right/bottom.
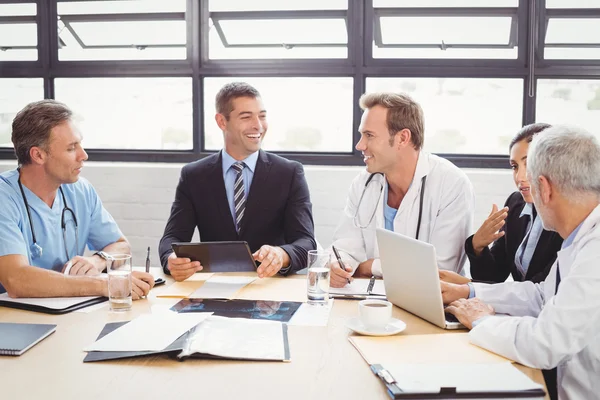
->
[[11, 100, 73, 165]]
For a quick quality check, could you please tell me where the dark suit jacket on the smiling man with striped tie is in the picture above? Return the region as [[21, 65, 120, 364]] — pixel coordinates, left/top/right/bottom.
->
[[159, 150, 316, 273]]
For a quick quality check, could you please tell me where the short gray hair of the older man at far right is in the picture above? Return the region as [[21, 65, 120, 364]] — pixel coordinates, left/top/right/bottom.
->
[[527, 125, 600, 200]]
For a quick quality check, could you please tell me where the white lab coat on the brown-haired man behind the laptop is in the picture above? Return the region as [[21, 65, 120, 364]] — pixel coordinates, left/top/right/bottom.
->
[[333, 152, 474, 277]]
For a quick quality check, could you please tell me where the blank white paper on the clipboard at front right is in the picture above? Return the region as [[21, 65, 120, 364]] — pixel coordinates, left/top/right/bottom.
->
[[383, 362, 541, 393]]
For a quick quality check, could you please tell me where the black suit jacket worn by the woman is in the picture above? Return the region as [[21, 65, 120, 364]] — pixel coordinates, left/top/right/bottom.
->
[[465, 192, 562, 282]]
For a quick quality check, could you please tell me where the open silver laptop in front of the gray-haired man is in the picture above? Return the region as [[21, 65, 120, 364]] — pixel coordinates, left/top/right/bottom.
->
[[377, 228, 464, 329]]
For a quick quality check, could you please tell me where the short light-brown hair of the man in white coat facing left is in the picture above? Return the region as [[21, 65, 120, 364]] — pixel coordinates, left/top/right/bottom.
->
[[359, 92, 425, 150]]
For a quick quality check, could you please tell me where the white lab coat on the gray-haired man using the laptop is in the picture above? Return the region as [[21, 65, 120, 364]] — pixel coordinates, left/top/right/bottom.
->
[[469, 206, 600, 400]]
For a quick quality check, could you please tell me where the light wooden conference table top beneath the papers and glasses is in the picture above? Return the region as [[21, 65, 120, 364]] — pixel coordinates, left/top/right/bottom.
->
[[0, 268, 543, 400]]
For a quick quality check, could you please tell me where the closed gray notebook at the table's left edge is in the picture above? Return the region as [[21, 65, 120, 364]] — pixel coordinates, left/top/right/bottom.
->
[[0, 322, 56, 356]]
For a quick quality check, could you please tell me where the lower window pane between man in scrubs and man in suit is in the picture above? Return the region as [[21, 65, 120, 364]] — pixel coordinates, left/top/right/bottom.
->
[[55, 78, 193, 150]]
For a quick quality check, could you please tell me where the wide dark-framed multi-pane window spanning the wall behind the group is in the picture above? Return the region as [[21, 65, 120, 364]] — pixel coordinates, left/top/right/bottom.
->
[[0, 0, 600, 168]]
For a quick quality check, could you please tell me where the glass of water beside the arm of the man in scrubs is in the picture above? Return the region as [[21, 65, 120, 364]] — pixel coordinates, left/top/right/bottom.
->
[[106, 254, 131, 311]]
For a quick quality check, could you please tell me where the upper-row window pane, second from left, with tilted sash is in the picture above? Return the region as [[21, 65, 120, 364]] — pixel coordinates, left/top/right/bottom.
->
[[58, 0, 187, 61]]
